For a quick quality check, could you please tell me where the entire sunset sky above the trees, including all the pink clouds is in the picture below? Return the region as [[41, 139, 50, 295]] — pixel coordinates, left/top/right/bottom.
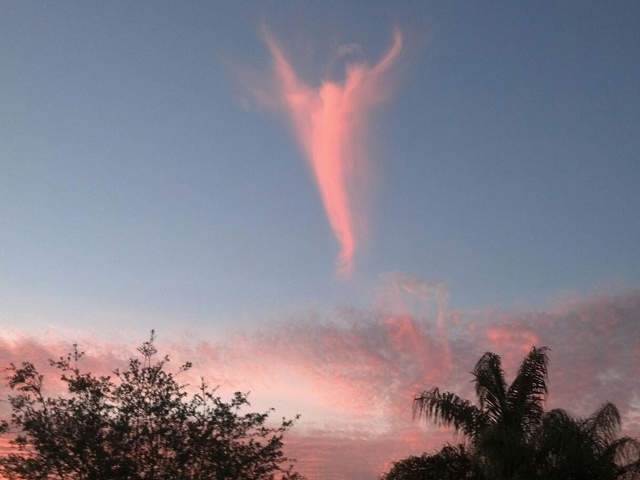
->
[[0, 1, 640, 479]]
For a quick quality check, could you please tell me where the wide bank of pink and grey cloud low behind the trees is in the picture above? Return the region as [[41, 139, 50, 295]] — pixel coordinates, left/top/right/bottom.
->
[[0, 286, 640, 479]]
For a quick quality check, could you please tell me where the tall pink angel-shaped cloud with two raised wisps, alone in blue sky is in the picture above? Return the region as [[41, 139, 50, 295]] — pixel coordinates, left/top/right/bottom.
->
[[265, 30, 402, 274]]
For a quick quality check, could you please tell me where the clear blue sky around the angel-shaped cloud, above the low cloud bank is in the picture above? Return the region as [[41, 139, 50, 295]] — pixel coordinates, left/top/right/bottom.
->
[[0, 1, 640, 329]]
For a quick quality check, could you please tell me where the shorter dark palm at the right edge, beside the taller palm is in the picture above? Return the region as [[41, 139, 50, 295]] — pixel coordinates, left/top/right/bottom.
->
[[536, 403, 640, 480]]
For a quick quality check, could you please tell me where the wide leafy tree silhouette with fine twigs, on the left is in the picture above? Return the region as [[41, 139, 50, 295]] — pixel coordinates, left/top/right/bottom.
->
[[0, 332, 300, 480]]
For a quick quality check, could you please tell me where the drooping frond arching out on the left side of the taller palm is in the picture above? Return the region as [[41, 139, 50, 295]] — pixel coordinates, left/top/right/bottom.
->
[[413, 388, 485, 437]]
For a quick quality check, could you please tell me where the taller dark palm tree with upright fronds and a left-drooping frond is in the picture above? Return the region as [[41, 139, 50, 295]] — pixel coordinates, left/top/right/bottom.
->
[[414, 347, 548, 480]]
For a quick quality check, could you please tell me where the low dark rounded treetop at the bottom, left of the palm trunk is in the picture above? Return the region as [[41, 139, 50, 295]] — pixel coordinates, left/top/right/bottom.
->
[[382, 445, 481, 480]]
